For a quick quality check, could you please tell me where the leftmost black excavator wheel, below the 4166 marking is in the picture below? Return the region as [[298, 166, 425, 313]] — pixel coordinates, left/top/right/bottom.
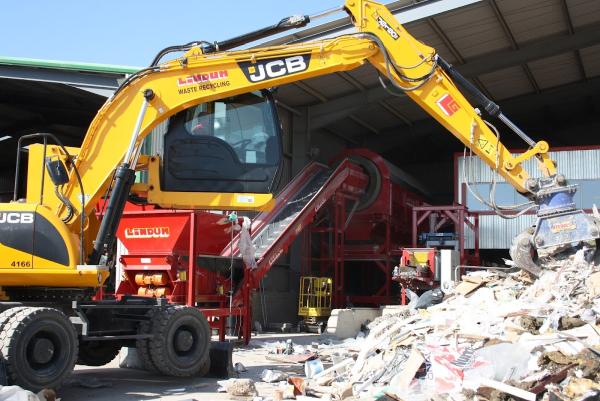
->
[[0, 308, 78, 392]]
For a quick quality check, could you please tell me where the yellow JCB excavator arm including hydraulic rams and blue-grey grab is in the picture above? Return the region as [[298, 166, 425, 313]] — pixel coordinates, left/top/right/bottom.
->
[[11, 0, 599, 278]]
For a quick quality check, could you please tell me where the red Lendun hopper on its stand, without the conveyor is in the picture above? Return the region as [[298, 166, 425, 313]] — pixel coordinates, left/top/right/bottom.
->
[[115, 207, 251, 342]]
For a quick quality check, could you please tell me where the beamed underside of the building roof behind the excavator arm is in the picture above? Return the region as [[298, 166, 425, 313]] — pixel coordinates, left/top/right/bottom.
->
[[267, 0, 600, 166]]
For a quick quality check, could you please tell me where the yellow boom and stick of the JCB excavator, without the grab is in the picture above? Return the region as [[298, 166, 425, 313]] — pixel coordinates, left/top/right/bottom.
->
[[53, 1, 556, 220]]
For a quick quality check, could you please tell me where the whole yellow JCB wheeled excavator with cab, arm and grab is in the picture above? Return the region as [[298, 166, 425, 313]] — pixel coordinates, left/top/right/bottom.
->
[[0, 0, 600, 390]]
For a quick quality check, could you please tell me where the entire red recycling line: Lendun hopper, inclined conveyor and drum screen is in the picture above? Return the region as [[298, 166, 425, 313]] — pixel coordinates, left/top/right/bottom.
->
[[109, 149, 440, 343]]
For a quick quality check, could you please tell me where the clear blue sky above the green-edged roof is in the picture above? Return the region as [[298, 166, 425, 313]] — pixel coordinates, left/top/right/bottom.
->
[[0, 0, 343, 66]]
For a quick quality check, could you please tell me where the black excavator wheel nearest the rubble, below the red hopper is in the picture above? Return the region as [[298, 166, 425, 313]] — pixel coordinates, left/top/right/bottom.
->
[[149, 306, 210, 377]]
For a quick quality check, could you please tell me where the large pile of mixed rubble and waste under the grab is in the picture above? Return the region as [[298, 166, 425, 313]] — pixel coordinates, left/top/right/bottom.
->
[[237, 258, 600, 401]]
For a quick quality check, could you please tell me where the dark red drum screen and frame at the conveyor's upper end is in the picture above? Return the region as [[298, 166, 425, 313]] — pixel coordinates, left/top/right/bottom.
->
[[301, 149, 424, 308]]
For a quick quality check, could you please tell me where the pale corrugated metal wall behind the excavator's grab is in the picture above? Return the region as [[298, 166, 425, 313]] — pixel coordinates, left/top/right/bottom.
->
[[455, 149, 600, 249]]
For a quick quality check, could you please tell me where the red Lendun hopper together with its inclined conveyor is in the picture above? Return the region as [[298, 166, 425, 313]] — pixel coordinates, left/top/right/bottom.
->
[[110, 161, 367, 344]]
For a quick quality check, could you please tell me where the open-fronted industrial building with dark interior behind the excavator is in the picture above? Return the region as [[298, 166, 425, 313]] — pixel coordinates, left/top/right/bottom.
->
[[0, 0, 600, 322]]
